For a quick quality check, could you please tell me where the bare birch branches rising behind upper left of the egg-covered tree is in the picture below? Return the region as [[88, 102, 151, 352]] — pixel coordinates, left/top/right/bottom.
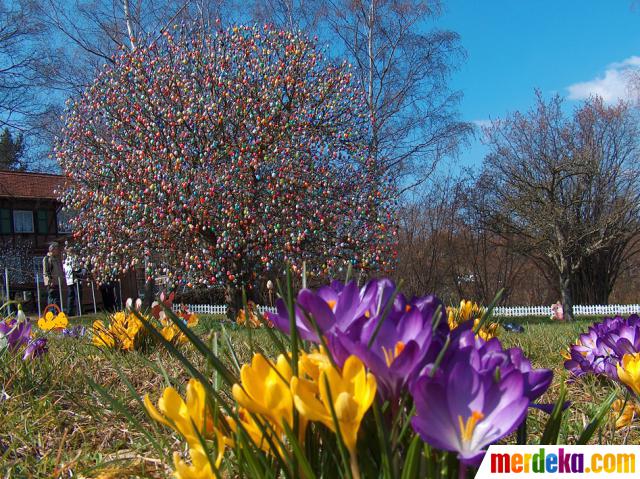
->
[[33, 0, 234, 95]]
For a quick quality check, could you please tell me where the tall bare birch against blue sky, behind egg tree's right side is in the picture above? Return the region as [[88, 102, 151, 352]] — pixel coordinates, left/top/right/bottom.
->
[[254, 0, 471, 194]]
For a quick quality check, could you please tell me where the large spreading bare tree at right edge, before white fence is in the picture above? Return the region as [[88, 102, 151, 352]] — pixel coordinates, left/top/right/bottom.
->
[[478, 93, 640, 317]]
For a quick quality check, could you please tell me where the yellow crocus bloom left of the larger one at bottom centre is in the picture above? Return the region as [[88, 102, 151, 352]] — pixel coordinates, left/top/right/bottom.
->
[[232, 354, 293, 426]]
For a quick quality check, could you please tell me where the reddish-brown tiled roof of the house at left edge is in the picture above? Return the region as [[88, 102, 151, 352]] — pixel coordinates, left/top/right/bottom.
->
[[0, 171, 64, 200]]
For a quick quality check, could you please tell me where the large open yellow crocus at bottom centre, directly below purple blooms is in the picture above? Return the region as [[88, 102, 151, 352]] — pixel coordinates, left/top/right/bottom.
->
[[291, 356, 376, 458]]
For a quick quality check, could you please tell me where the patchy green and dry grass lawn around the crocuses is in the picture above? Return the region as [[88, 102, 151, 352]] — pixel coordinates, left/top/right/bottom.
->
[[0, 316, 640, 479]]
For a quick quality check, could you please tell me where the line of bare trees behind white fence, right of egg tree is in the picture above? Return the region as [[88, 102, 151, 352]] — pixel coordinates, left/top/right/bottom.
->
[[398, 94, 640, 318]]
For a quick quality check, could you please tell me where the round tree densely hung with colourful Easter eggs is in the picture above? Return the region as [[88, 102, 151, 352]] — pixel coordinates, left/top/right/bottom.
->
[[56, 26, 395, 314]]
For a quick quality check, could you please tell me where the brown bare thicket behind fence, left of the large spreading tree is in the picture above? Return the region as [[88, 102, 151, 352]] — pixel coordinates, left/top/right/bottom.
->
[[396, 172, 527, 304]]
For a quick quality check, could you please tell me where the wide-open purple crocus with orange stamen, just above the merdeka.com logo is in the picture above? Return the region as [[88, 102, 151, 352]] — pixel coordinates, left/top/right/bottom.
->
[[410, 360, 529, 465]]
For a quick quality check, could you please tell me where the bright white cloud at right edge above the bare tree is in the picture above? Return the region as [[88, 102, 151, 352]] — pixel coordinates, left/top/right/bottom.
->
[[567, 56, 640, 103]]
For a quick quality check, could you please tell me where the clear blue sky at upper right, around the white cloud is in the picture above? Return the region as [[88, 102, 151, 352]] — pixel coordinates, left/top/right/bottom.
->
[[437, 0, 640, 170]]
